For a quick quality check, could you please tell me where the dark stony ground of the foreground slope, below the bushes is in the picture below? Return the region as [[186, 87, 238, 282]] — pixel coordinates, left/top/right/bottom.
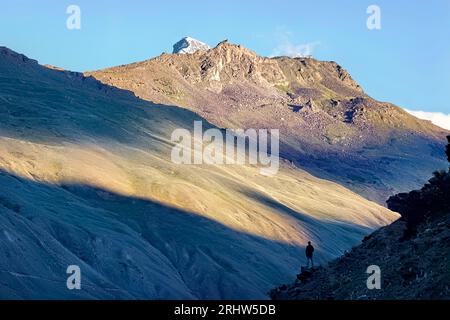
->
[[271, 213, 450, 300]]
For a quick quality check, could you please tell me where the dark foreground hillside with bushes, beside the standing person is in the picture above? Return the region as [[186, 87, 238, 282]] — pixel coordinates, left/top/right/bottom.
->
[[271, 162, 450, 300]]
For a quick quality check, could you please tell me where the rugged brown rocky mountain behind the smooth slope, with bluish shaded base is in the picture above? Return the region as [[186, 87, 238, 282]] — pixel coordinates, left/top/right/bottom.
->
[[86, 41, 447, 204]]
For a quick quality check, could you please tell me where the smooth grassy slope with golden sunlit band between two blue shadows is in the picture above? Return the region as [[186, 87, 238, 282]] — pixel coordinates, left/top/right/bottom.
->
[[0, 48, 398, 299]]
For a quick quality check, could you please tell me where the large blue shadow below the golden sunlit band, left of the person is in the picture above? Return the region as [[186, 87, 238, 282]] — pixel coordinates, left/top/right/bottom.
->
[[0, 171, 354, 299]]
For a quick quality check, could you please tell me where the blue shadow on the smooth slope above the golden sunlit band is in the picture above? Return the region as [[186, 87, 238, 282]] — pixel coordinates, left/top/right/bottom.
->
[[0, 60, 206, 146]]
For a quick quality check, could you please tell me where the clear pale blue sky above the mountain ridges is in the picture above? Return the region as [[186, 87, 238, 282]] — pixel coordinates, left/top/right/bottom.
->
[[0, 0, 450, 113]]
